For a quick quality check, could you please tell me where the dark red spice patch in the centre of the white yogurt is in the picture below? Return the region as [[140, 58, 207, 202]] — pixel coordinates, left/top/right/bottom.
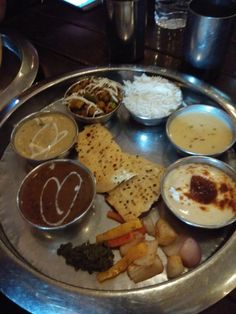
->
[[187, 175, 217, 204]]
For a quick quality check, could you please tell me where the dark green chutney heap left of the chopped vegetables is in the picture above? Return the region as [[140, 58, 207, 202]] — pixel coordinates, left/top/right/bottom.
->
[[57, 242, 114, 274]]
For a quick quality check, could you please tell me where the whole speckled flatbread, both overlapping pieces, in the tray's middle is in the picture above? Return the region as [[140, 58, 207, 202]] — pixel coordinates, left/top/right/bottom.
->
[[77, 124, 164, 221]]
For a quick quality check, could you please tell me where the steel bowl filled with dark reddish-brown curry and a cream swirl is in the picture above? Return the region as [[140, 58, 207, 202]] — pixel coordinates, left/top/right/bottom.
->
[[17, 159, 96, 231]]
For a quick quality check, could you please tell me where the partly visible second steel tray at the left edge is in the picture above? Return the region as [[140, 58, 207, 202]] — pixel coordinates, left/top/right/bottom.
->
[[0, 32, 39, 115]]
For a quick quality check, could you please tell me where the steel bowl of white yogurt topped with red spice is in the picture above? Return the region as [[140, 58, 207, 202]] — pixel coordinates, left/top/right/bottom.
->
[[161, 156, 236, 229]]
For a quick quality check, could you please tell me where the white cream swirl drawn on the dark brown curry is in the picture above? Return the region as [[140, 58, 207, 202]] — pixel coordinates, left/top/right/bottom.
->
[[40, 171, 83, 226]]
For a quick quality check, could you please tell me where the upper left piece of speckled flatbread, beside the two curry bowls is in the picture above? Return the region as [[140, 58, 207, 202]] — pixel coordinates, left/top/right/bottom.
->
[[77, 124, 136, 193]]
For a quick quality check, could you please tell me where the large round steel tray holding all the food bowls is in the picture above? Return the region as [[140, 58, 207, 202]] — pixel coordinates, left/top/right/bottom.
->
[[0, 66, 236, 314]]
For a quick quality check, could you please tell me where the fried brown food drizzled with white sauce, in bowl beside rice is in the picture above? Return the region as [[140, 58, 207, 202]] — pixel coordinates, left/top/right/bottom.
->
[[64, 76, 123, 118]]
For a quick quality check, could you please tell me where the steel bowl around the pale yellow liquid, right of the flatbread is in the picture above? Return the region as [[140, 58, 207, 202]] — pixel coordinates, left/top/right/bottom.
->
[[166, 104, 236, 157]]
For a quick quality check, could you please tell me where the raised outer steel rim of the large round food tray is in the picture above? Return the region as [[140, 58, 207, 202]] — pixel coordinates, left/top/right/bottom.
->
[[0, 66, 236, 313]]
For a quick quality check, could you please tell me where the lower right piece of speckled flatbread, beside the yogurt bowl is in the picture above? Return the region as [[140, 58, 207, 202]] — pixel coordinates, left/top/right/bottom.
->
[[106, 156, 164, 221]]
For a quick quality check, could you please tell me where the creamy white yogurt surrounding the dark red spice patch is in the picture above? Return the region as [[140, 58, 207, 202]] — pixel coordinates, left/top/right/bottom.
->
[[163, 164, 236, 226]]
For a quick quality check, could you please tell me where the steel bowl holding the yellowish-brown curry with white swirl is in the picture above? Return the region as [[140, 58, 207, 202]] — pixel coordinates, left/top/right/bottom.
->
[[11, 111, 78, 164]]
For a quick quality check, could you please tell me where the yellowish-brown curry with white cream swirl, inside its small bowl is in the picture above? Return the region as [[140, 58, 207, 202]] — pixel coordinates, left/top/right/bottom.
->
[[13, 112, 77, 160]]
